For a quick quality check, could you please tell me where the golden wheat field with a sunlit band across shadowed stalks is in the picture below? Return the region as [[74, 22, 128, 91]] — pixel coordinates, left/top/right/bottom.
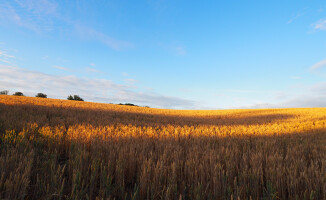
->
[[0, 95, 326, 199]]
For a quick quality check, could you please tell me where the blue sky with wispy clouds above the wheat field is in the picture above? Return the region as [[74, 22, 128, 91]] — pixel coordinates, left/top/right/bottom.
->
[[0, 0, 326, 109]]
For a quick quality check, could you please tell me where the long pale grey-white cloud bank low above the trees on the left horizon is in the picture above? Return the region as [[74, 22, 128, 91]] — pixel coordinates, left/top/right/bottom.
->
[[0, 65, 196, 109]]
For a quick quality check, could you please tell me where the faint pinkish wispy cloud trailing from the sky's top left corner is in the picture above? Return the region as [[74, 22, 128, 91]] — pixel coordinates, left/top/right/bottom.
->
[[0, 0, 134, 50]]
